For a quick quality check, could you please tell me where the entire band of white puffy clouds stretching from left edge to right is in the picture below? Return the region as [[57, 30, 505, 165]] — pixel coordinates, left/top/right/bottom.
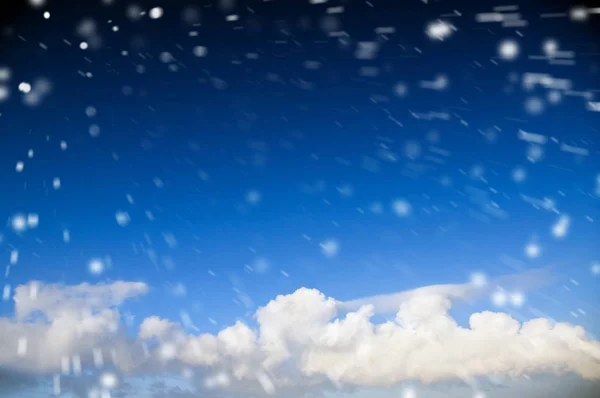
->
[[0, 282, 600, 396]]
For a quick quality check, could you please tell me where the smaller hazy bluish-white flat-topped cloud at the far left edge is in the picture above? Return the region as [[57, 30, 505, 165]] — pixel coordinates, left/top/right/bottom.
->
[[0, 282, 148, 373]]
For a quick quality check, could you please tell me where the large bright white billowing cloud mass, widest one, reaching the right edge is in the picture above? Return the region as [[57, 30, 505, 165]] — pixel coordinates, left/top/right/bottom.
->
[[135, 285, 600, 395]]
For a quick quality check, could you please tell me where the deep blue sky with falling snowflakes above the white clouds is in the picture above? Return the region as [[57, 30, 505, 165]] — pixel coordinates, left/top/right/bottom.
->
[[0, 1, 600, 398]]
